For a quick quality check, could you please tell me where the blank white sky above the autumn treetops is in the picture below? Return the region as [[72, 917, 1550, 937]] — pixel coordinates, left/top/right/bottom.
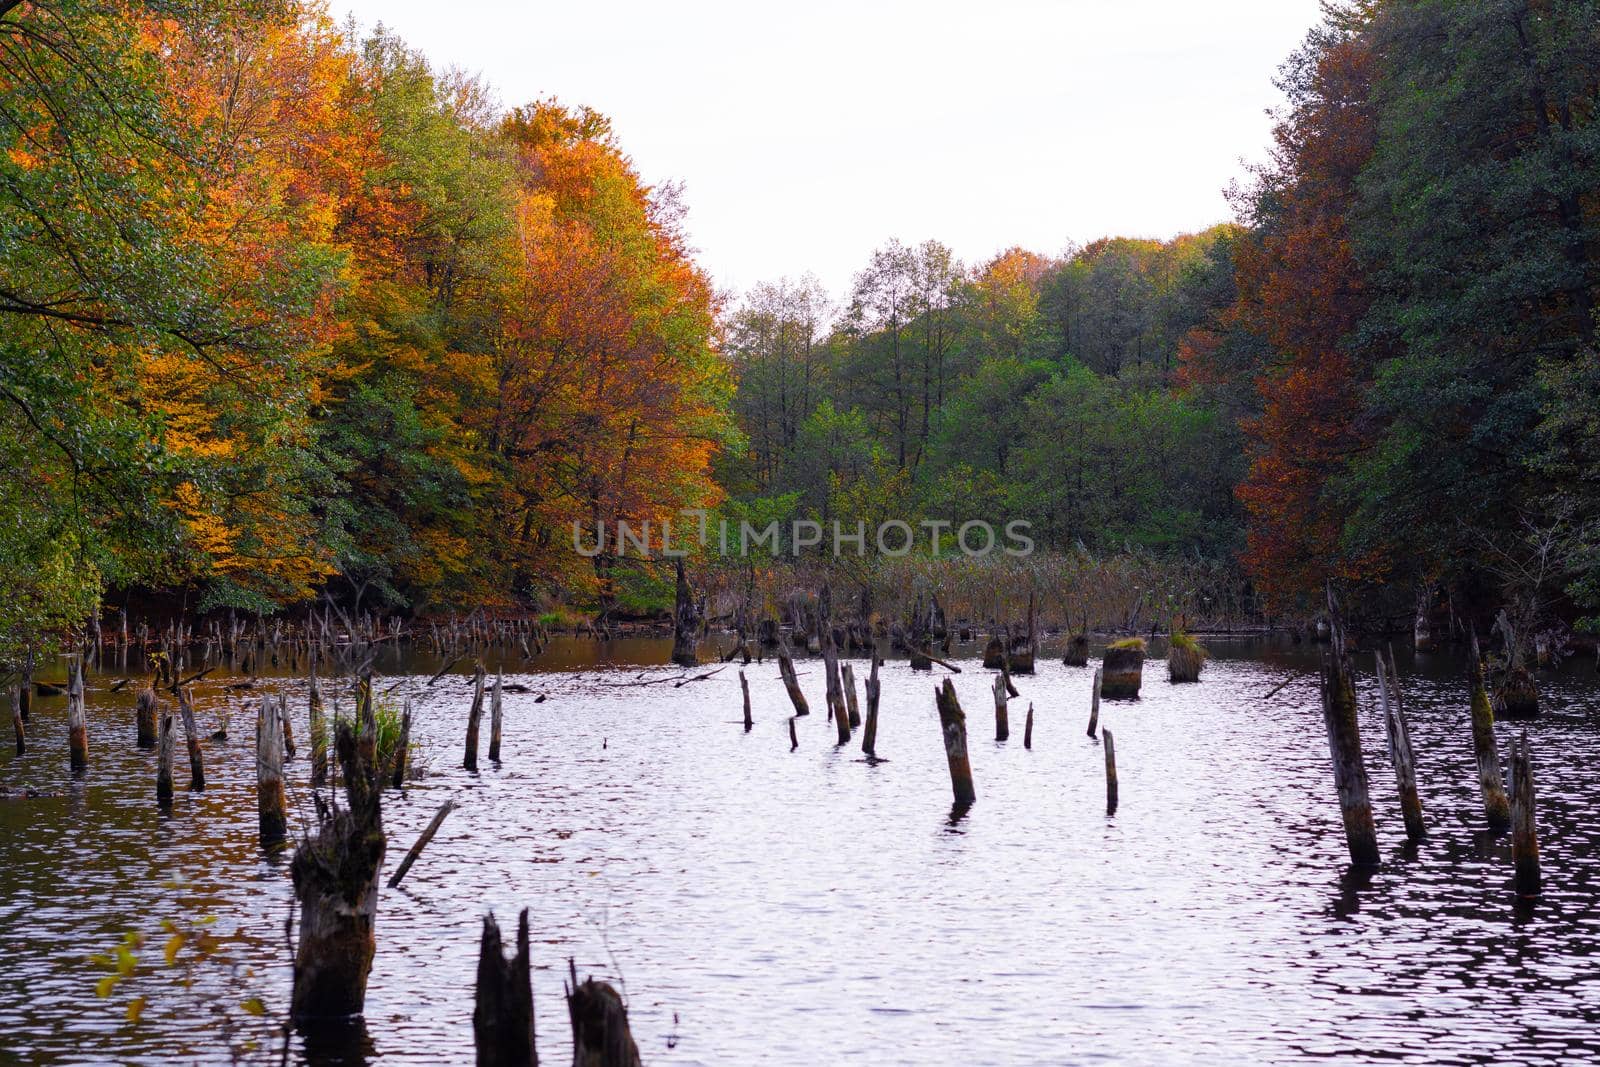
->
[[330, 0, 1318, 296]]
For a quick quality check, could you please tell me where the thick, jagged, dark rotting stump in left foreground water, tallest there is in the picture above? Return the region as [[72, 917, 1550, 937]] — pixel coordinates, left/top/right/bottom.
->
[[290, 721, 387, 1022]]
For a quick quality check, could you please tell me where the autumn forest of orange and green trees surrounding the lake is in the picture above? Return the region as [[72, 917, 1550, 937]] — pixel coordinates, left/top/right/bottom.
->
[[0, 0, 1600, 659]]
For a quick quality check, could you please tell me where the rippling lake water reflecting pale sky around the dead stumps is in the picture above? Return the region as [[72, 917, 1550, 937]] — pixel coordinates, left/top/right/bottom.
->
[[0, 640, 1600, 1065]]
